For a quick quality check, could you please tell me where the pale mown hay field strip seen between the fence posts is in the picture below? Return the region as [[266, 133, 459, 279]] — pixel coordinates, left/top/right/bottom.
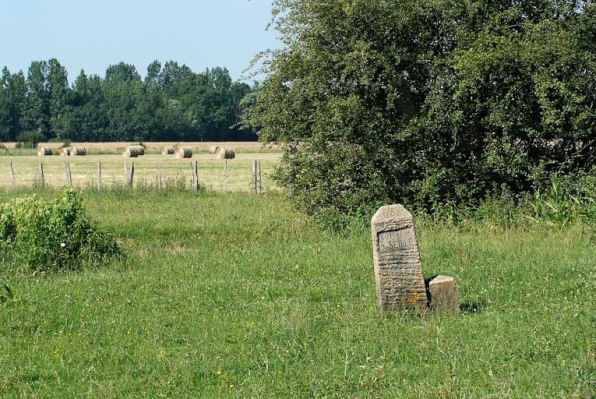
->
[[0, 152, 281, 192]]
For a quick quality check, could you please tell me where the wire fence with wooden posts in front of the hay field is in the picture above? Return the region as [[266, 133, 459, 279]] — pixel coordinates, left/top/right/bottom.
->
[[0, 154, 278, 194]]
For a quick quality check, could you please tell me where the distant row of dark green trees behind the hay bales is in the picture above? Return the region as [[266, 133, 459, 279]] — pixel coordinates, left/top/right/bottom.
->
[[0, 59, 257, 143]]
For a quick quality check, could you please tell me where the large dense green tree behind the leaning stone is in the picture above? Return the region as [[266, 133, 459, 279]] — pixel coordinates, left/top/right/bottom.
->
[[247, 0, 596, 219]]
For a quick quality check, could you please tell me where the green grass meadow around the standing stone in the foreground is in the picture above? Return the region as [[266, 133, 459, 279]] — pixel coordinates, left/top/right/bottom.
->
[[0, 190, 596, 398]]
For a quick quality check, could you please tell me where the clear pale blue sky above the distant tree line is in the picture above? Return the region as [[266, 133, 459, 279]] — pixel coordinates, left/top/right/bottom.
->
[[0, 0, 278, 82]]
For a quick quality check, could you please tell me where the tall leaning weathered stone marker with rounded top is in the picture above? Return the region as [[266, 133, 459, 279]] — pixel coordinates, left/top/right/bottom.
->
[[371, 205, 428, 311]]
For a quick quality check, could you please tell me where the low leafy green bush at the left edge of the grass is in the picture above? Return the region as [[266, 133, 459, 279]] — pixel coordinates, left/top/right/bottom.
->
[[0, 188, 121, 270]]
